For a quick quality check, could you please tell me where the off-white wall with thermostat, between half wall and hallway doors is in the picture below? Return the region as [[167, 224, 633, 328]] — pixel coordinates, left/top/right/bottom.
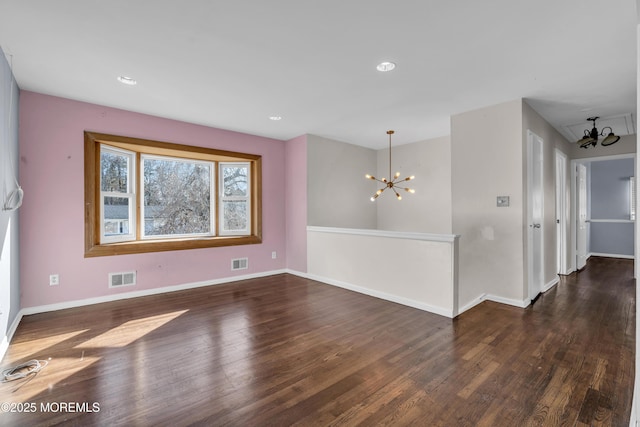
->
[[451, 100, 526, 307]]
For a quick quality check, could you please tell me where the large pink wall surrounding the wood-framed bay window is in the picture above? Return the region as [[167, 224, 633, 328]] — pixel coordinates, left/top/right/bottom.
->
[[20, 91, 288, 308]]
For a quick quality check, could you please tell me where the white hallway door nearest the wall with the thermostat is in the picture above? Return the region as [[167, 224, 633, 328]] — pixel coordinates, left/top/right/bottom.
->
[[527, 131, 544, 301]]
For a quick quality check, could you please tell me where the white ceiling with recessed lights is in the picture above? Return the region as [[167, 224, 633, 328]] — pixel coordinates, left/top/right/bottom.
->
[[0, 0, 637, 148]]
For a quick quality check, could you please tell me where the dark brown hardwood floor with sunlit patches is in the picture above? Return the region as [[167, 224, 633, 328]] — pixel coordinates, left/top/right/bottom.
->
[[0, 258, 635, 426]]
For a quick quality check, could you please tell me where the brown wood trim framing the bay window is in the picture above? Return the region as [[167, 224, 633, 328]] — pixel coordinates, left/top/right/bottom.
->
[[84, 131, 262, 258]]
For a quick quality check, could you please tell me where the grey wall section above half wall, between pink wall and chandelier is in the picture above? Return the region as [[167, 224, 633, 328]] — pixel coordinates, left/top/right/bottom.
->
[[308, 135, 376, 229]]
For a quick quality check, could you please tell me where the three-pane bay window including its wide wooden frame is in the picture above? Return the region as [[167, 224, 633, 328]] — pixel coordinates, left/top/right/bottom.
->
[[85, 132, 262, 257]]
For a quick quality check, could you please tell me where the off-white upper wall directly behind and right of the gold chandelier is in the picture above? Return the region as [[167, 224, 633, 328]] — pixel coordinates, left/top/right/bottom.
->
[[371, 136, 451, 234]]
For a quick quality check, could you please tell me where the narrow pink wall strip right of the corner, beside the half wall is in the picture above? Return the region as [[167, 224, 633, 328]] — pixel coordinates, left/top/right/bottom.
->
[[285, 135, 307, 273]]
